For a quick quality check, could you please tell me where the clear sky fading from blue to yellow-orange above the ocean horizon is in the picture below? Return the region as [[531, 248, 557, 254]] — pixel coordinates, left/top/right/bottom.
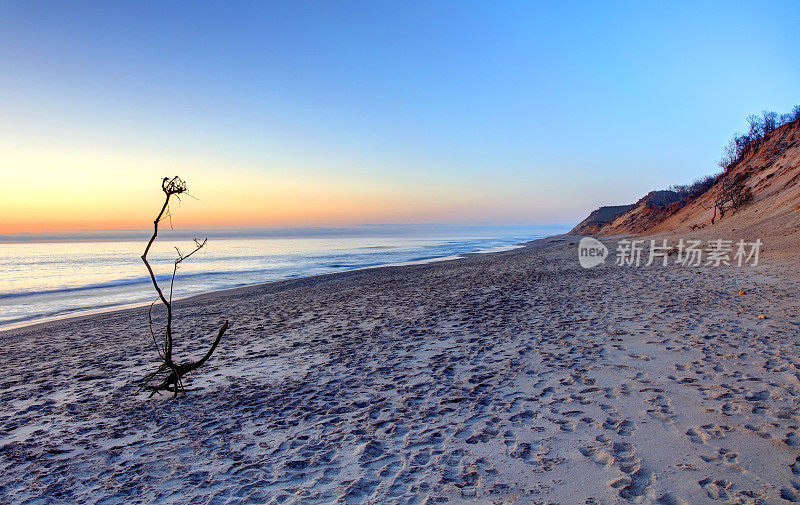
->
[[0, 0, 800, 233]]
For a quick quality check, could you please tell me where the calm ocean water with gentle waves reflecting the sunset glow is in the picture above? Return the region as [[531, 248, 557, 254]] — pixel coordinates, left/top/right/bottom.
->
[[0, 226, 564, 330]]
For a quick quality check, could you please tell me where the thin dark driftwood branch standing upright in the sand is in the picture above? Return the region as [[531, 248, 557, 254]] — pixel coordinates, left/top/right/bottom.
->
[[140, 176, 228, 397]]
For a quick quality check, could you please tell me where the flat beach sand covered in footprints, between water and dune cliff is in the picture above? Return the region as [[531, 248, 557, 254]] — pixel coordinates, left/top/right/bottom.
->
[[0, 237, 800, 505]]
